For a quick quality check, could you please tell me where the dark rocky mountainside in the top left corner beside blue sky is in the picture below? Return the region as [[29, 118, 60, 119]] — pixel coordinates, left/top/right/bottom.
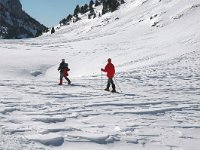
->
[[0, 0, 47, 39]]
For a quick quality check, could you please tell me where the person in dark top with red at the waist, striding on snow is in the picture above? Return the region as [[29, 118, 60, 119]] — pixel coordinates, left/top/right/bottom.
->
[[58, 59, 71, 85]]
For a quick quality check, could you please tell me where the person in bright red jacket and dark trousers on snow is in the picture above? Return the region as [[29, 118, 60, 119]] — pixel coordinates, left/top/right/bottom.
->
[[101, 58, 116, 92]]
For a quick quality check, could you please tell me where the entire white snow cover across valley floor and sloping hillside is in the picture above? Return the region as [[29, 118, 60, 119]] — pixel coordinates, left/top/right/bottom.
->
[[0, 0, 200, 150]]
